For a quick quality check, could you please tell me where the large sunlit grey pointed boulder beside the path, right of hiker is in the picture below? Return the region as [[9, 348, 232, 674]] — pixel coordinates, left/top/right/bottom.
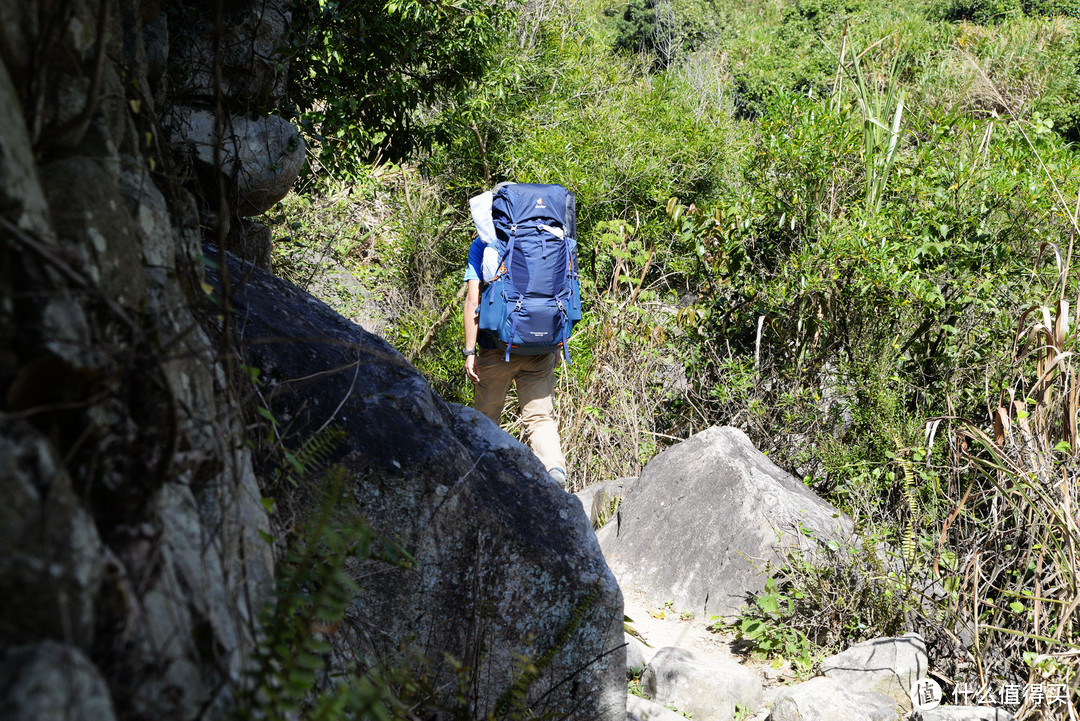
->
[[597, 427, 852, 617]]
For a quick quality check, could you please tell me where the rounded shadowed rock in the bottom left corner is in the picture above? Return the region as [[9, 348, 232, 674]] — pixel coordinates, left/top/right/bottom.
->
[[0, 641, 116, 721]]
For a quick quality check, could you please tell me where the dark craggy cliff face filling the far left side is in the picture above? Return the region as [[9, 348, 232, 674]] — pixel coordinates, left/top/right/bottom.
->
[[0, 0, 273, 720]]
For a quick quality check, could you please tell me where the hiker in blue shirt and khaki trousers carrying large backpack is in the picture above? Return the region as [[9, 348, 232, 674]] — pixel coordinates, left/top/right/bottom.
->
[[462, 183, 581, 488]]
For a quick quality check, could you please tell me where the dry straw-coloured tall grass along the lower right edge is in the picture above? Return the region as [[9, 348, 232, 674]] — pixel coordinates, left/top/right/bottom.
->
[[915, 69, 1080, 719]]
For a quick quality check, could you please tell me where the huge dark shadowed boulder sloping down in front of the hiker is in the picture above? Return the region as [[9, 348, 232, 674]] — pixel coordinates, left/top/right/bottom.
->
[[209, 249, 626, 721]]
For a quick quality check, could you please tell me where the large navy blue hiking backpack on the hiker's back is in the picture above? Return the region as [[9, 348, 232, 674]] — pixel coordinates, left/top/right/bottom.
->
[[470, 182, 581, 363]]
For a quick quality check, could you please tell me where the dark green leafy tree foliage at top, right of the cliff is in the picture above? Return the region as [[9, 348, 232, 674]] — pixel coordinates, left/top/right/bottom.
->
[[289, 0, 504, 176]]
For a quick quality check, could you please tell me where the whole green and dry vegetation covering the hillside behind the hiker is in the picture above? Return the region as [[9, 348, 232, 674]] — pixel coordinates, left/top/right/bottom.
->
[[261, 0, 1080, 718]]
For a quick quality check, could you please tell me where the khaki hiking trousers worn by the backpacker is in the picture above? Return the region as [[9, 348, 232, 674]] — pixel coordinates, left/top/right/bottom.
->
[[473, 349, 566, 471]]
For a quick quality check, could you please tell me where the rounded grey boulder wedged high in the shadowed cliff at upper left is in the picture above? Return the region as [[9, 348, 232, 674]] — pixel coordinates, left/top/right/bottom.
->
[[170, 107, 305, 216]]
